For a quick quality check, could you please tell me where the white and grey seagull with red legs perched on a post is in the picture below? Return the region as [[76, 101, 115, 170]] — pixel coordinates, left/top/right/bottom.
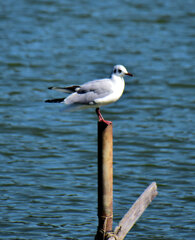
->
[[45, 65, 133, 125]]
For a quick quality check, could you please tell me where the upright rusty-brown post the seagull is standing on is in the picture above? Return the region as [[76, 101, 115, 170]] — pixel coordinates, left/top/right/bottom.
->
[[95, 121, 113, 240]]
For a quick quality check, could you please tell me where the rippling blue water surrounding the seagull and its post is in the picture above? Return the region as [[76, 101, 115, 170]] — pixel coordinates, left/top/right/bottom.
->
[[0, 0, 195, 240]]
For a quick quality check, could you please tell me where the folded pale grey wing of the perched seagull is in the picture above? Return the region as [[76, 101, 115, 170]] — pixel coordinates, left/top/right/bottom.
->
[[65, 79, 112, 105]]
